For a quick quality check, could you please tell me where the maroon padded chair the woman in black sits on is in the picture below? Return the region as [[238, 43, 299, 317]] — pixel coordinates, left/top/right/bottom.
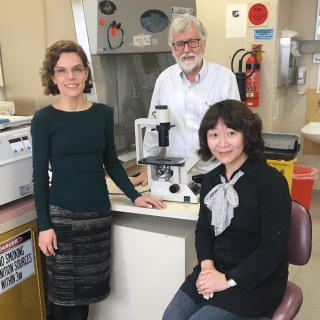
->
[[261, 200, 312, 320]]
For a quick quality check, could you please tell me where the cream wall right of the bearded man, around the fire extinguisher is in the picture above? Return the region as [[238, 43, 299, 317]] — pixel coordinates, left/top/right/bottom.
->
[[197, 0, 320, 190]]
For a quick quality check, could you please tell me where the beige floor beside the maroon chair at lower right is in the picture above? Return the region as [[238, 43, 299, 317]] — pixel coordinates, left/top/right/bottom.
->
[[289, 191, 320, 320]]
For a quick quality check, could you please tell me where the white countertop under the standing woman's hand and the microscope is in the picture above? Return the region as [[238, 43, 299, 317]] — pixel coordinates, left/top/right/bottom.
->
[[107, 179, 200, 220]]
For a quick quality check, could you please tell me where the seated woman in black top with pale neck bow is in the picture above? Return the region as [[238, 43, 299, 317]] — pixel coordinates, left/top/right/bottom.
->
[[163, 100, 291, 320]]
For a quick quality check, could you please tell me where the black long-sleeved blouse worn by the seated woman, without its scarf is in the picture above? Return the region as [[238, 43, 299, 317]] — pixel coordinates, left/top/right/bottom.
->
[[181, 158, 291, 317]]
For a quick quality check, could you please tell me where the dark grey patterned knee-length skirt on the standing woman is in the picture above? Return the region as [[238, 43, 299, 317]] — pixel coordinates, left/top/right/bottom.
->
[[47, 205, 111, 306]]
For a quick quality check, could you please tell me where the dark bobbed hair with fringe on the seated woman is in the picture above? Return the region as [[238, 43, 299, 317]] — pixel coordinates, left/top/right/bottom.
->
[[198, 100, 264, 161]]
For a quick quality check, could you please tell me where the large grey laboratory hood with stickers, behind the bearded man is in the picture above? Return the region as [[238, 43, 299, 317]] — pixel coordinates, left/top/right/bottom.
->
[[71, 0, 196, 158]]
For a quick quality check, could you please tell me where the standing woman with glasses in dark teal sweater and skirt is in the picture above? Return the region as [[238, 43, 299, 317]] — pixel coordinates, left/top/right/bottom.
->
[[31, 41, 165, 320]]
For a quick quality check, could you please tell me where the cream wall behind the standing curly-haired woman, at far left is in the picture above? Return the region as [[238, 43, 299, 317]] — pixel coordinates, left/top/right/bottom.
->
[[0, 0, 76, 115]]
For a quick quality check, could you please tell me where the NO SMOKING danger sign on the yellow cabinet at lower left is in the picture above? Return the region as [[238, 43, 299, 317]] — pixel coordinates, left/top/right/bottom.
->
[[0, 229, 36, 294]]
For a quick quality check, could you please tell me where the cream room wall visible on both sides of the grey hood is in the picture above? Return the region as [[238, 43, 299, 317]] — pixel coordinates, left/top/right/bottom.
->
[[0, 0, 320, 190]]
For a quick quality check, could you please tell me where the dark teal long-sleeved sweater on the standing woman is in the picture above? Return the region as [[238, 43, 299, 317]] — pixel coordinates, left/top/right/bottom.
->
[[31, 103, 140, 231]]
